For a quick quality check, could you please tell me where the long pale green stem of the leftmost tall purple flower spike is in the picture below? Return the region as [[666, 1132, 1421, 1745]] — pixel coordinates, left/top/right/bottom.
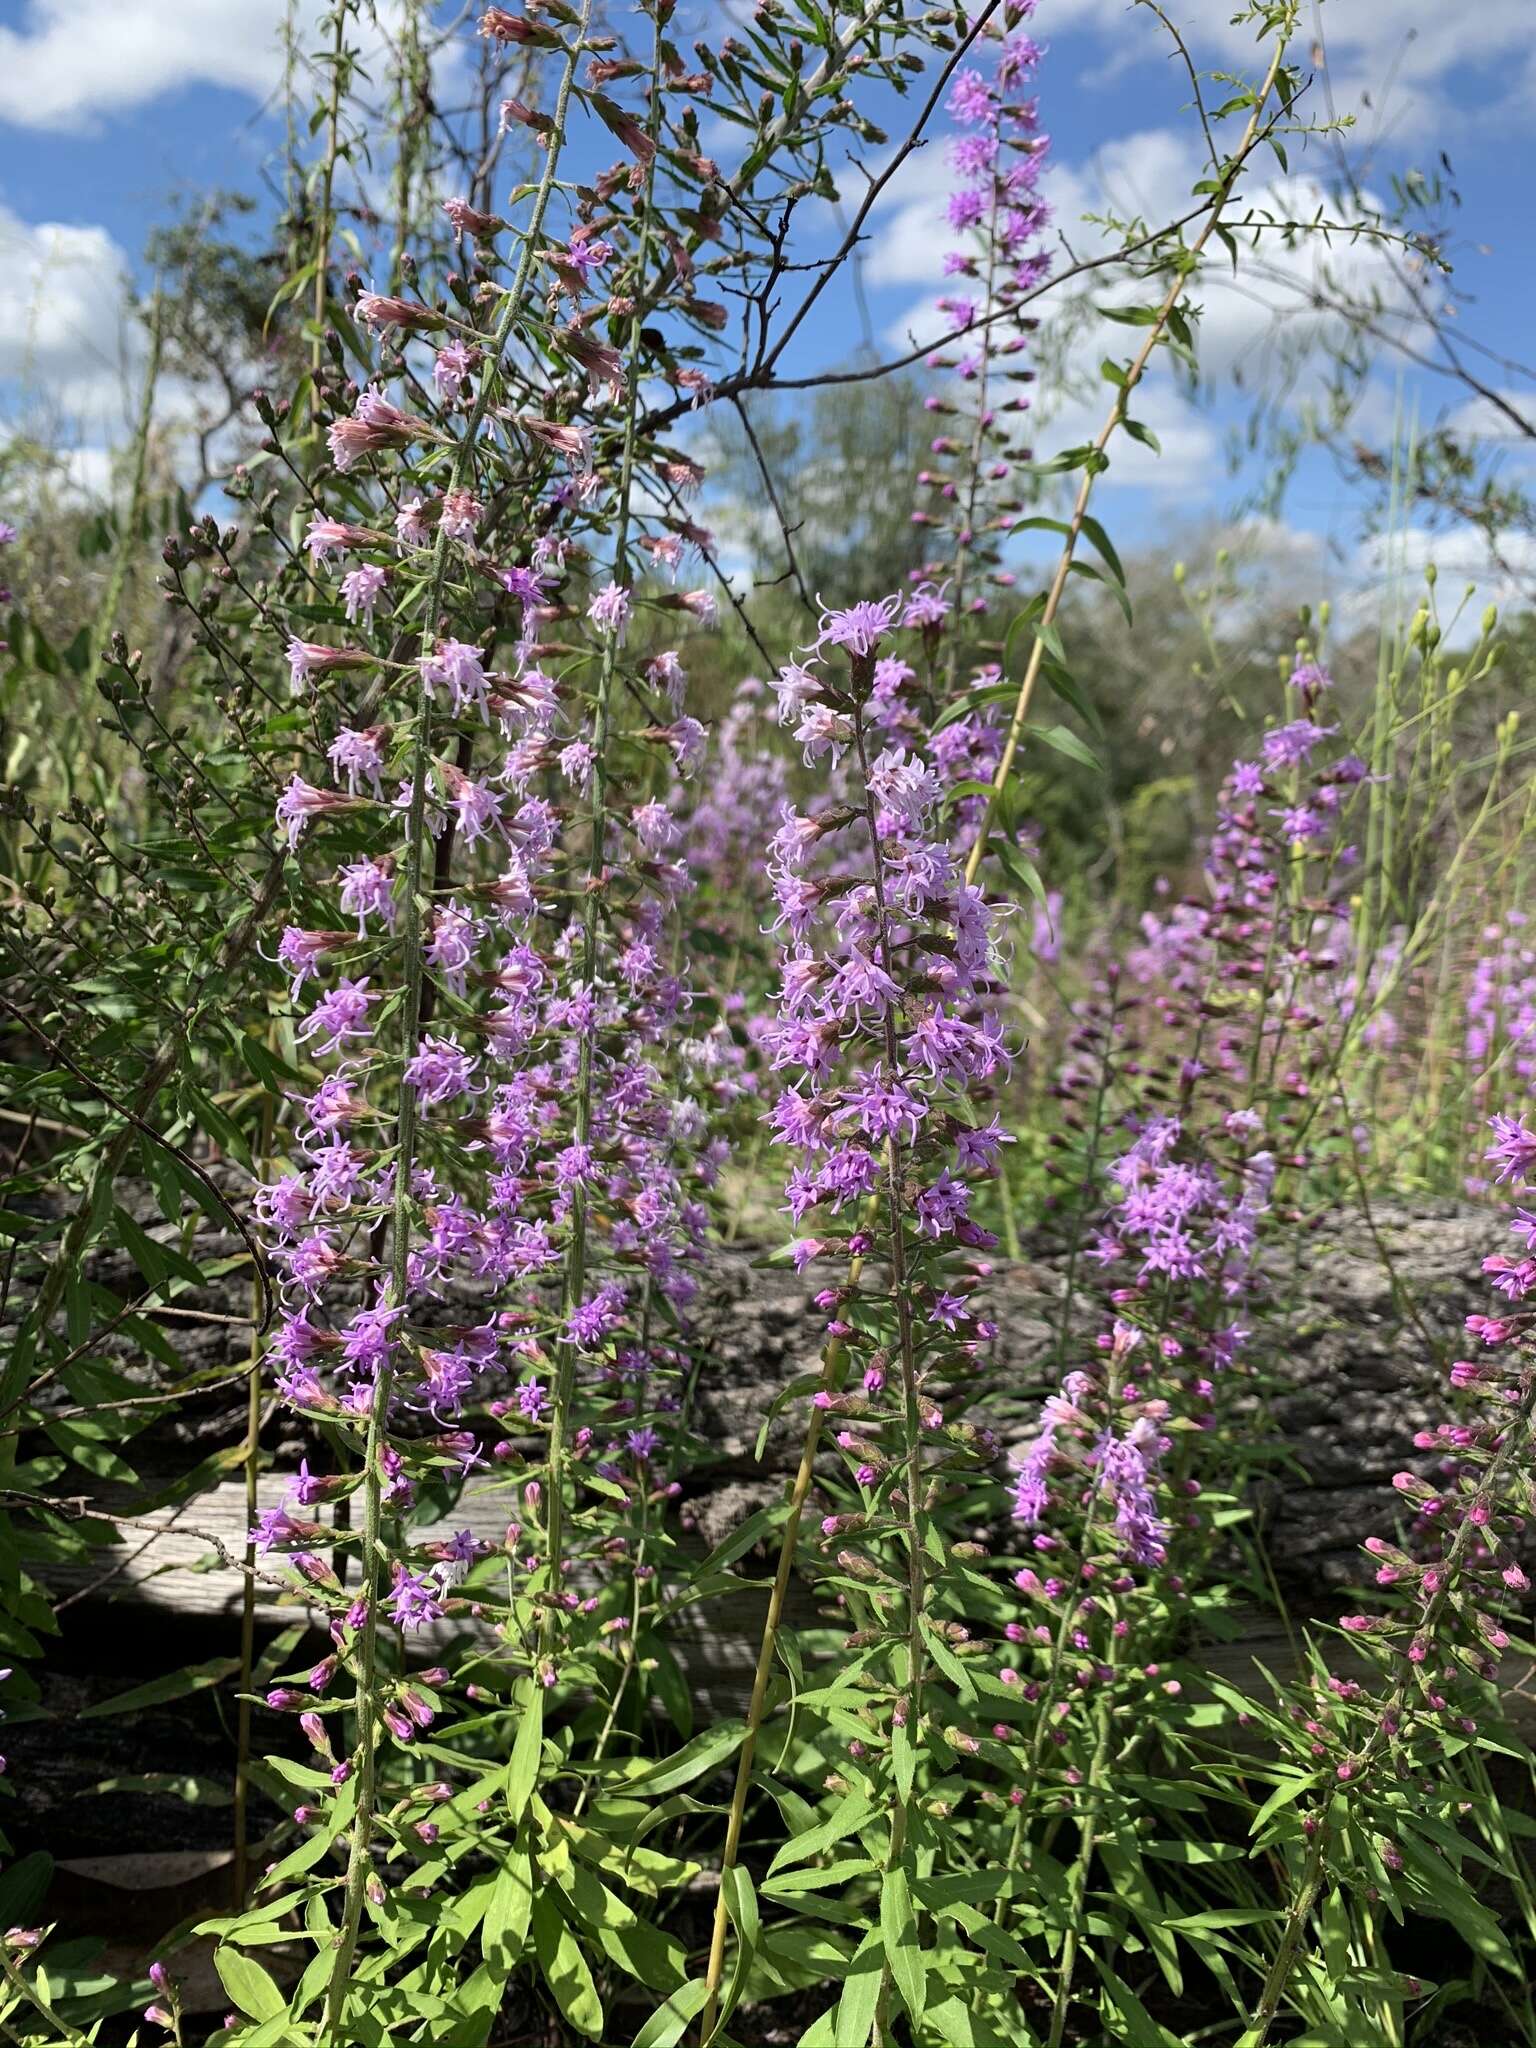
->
[[319, 12, 592, 2042]]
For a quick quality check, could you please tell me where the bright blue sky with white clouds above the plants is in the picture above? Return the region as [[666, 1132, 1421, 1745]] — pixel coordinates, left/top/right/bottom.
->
[[0, 0, 1536, 614]]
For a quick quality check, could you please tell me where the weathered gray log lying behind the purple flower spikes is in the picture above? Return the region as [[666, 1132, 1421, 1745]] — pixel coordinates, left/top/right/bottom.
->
[[30, 1202, 1499, 1638]]
